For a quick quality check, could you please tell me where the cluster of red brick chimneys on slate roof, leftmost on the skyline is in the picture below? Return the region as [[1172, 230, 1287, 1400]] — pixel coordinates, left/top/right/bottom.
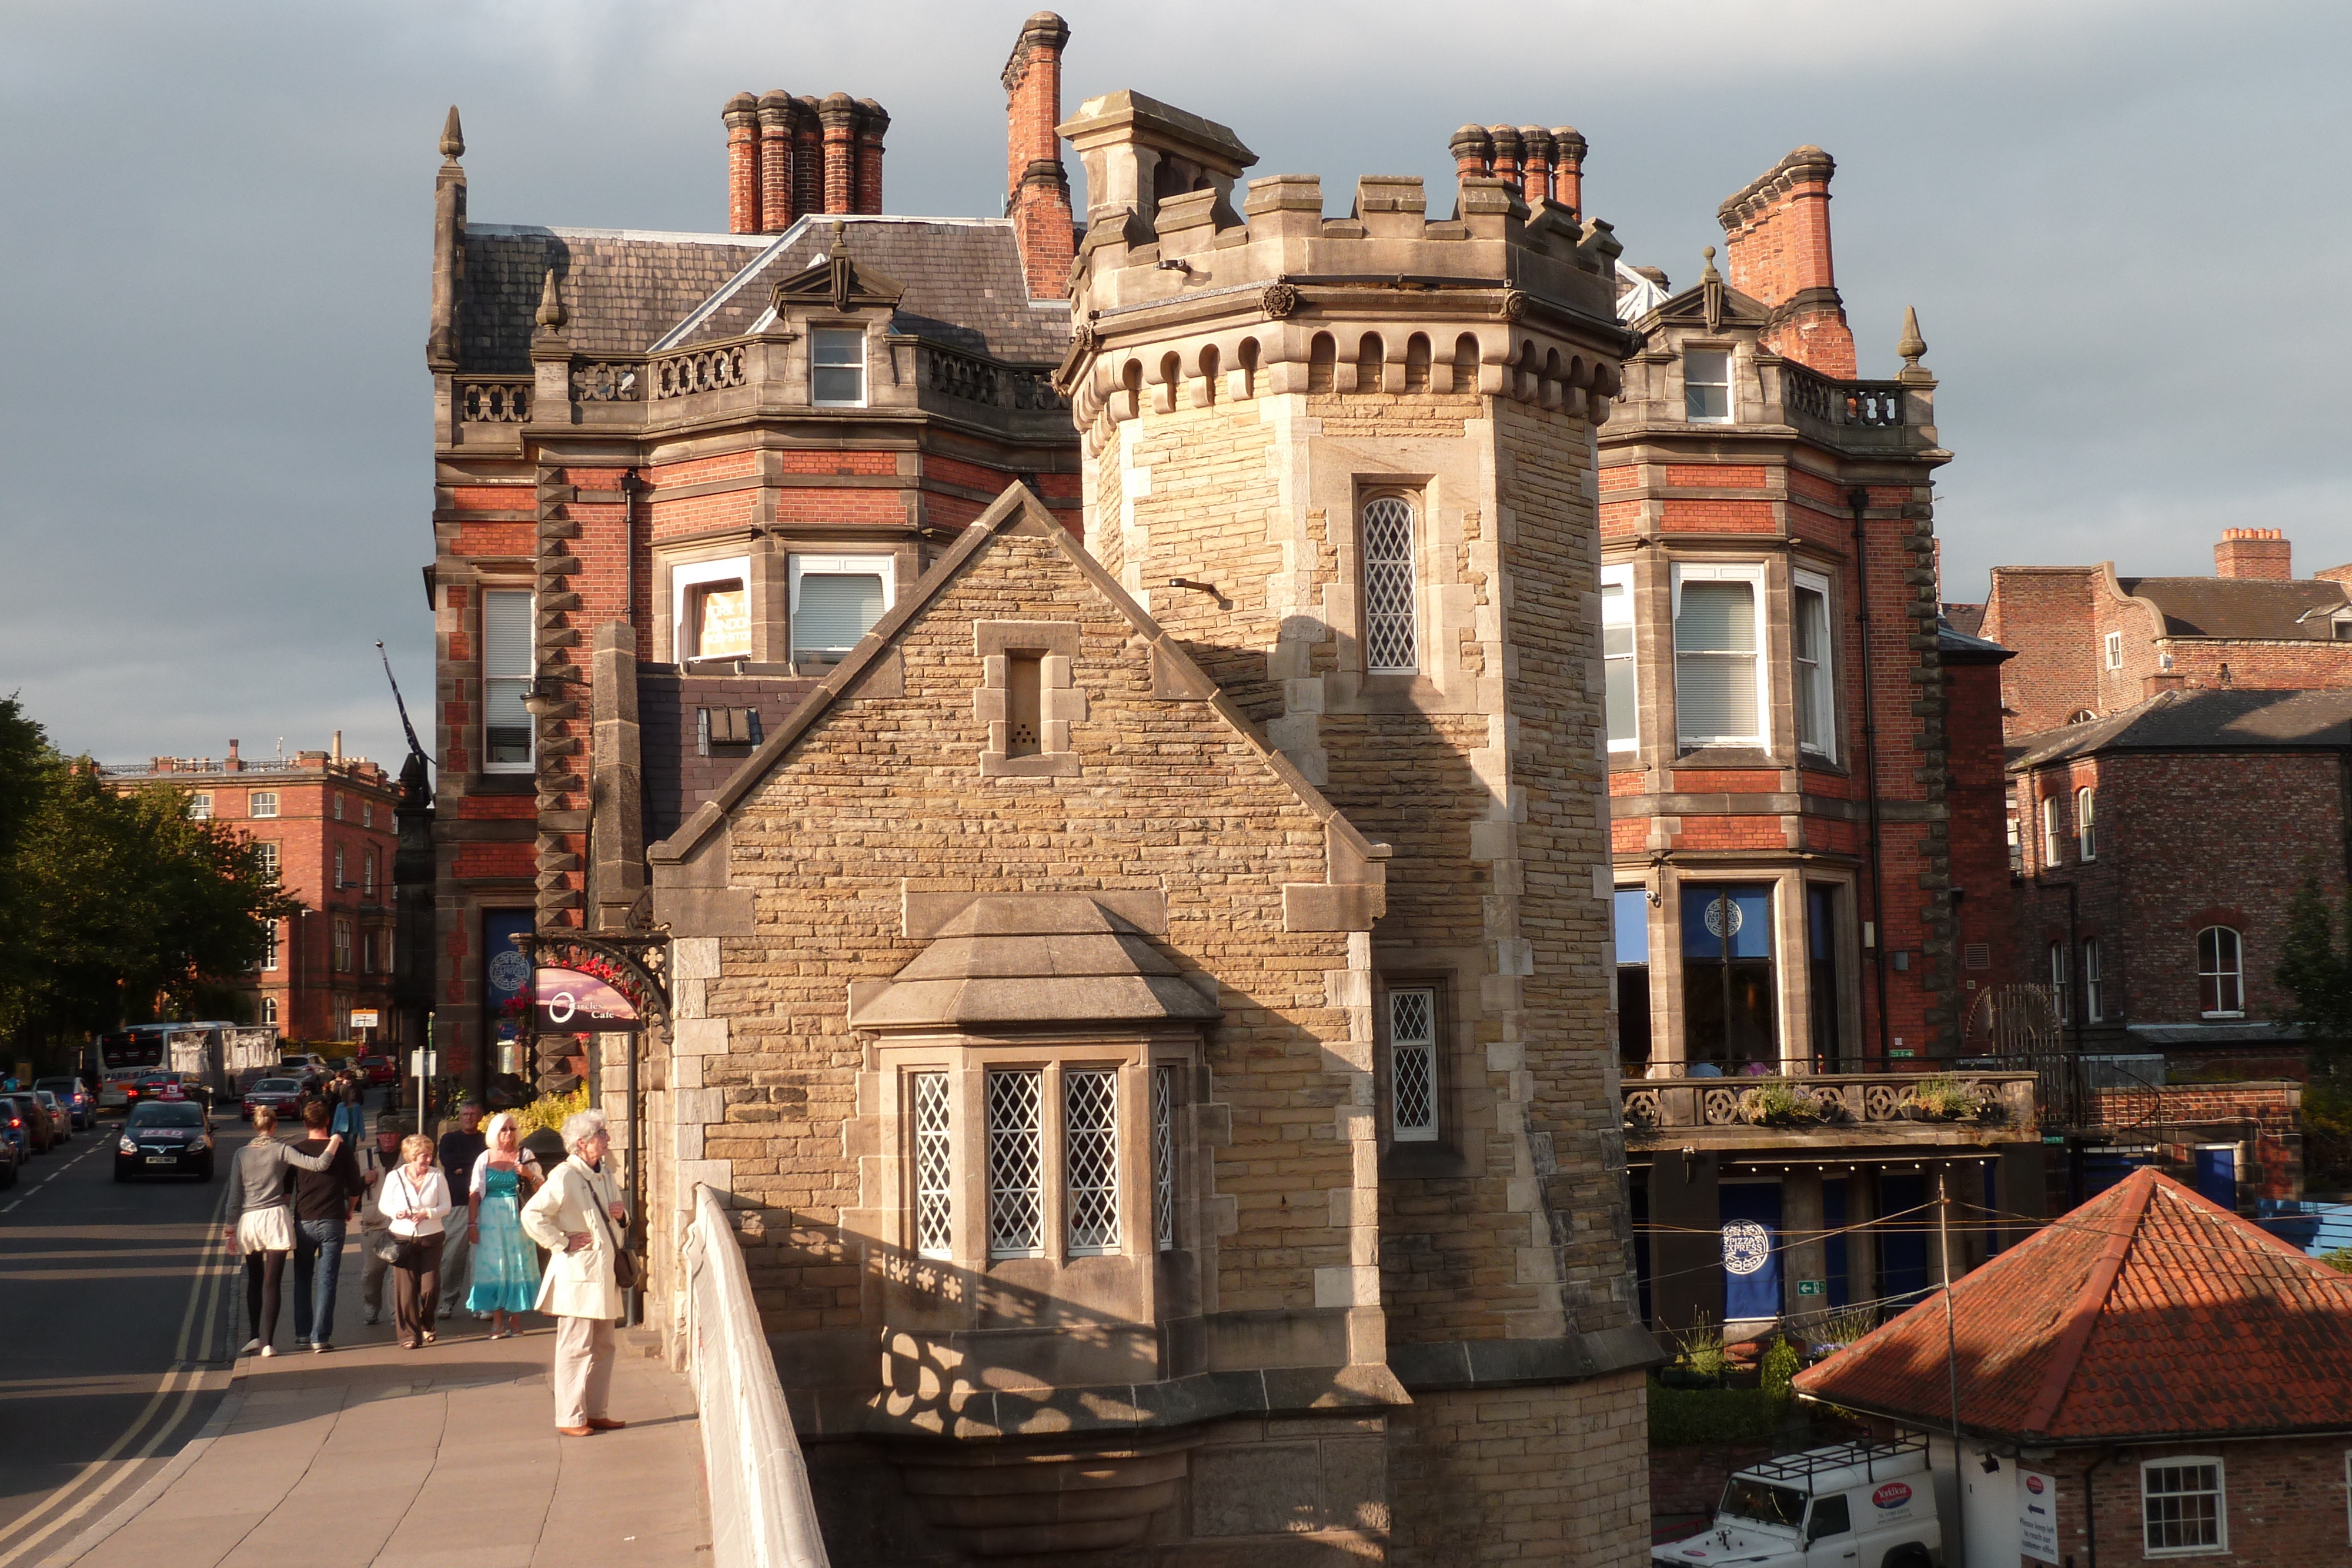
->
[[720, 89, 889, 235]]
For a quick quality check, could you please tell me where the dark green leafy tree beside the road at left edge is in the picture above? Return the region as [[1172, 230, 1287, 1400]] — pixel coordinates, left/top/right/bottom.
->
[[0, 698, 299, 1053]]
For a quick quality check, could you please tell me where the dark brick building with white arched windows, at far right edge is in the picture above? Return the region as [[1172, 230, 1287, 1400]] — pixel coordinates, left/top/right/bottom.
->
[[2009, 687, 2352, 1206]]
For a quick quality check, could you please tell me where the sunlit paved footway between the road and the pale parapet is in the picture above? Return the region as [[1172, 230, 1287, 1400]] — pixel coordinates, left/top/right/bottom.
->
[[14, 1114, 710, 1568]]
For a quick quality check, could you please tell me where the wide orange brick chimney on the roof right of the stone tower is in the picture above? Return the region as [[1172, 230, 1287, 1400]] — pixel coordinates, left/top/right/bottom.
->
[[1715, 146, 1856, 381]]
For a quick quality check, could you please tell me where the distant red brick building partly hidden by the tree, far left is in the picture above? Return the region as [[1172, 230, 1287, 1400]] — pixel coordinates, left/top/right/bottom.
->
[[106, 734, 397, 1041]]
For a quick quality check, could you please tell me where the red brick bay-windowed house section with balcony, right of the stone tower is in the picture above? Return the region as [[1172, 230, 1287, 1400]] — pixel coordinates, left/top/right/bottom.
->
[[1599, 143, 2042, 1328]]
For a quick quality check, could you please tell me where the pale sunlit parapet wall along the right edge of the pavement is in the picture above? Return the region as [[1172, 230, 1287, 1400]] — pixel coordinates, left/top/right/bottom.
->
[[682, 1185, 828, 1568]]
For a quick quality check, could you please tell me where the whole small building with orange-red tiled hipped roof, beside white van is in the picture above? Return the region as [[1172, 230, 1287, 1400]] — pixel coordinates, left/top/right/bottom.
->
[[1797, 1171, 2352, 1568]]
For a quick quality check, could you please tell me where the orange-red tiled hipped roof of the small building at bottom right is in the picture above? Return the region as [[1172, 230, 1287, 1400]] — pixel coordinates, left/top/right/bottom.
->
[[1797, 1168, 2352, 1441]]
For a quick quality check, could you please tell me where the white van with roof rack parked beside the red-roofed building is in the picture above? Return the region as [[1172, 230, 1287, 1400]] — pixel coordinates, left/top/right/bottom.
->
[[1649, 1439, 1943, 1568]]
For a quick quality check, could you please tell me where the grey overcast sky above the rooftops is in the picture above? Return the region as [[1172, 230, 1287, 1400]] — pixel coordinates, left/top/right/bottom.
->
[[0, 0, 2352, 764]]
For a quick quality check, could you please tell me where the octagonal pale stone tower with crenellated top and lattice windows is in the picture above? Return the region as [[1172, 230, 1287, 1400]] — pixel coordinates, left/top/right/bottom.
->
[[1061, 92, 1656, 1563]]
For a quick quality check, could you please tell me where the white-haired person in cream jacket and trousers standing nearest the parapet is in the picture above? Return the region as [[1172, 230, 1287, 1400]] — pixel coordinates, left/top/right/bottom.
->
[[522, 1109, 635, 1436]]
